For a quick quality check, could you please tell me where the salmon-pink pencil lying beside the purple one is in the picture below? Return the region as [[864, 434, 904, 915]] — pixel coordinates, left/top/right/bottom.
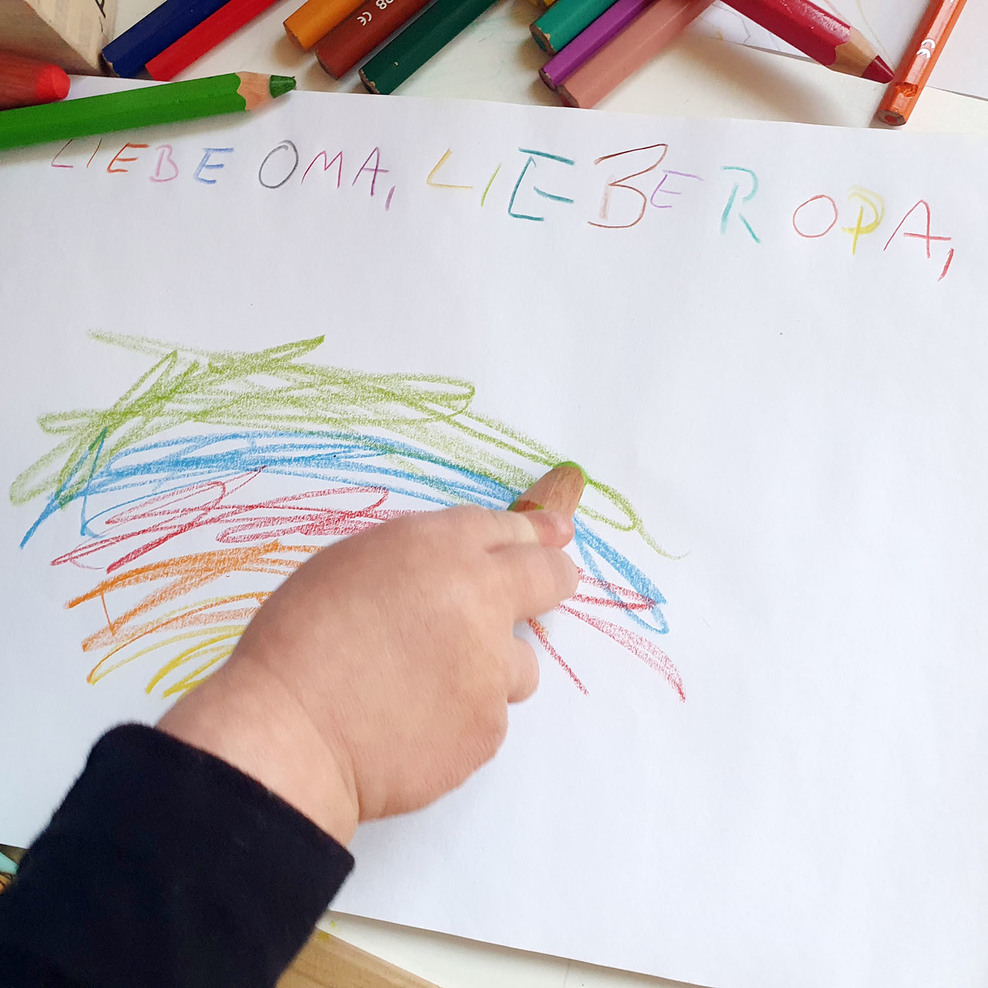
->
[[558, 0, 713, 107]]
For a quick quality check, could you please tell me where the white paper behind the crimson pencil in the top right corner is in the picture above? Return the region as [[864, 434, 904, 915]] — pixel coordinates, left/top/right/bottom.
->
[[691, 0, 988, 99]]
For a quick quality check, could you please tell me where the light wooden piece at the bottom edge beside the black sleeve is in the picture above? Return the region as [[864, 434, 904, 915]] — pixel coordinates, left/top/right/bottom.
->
[[278, 930, 438, 988]]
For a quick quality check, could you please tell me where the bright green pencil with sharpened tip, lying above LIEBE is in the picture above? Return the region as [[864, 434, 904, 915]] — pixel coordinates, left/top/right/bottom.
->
[[0, 72, 295, 149]]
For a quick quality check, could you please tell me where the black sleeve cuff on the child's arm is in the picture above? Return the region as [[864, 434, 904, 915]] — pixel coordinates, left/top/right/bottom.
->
[[0, 724, 353, 988]]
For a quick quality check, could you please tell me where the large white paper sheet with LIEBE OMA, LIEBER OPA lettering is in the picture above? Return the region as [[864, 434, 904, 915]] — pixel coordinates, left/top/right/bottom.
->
[[0, 87, 988, 988]]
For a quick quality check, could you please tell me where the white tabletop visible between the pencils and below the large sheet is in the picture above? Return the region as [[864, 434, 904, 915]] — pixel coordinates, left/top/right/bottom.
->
[[98, 0, 988, 988]]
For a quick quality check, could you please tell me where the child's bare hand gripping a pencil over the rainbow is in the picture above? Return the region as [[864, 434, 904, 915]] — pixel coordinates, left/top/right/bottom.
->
[[159, 507, 577, 843]]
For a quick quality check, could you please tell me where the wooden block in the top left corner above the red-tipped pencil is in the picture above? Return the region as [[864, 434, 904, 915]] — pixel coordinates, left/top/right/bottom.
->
[[0, 0, 117, 75]]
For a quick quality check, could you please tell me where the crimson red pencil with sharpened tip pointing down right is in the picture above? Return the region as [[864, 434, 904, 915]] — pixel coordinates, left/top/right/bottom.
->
[[724, 0, 892, 82]]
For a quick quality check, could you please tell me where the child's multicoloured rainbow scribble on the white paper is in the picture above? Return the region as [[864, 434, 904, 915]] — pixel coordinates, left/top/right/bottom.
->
[[10, 334, 685, 699]]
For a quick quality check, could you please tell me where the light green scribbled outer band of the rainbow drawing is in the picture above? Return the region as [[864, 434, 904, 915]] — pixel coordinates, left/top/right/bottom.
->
[[9, 333, 669, 556]]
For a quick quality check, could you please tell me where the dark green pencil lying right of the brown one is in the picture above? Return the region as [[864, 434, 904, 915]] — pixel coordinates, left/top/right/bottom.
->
[[360, 0, 496, 93]]
